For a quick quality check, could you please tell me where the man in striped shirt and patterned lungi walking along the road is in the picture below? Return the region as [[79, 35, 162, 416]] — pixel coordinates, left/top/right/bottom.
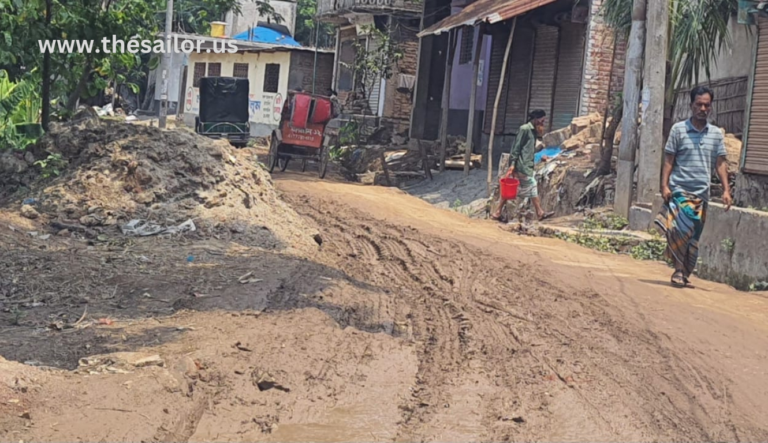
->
[[656, 87, 732, 287]]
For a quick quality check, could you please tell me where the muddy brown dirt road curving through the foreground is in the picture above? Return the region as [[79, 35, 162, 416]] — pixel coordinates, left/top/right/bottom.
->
[[0, 174, 768, 441]]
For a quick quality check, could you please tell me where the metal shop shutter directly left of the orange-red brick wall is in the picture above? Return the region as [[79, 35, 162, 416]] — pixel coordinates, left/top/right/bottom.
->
[[552, 23, 586, 130]]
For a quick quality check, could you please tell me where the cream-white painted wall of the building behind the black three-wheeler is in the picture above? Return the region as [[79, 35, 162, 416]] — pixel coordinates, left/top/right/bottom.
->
[[184, 48, 291, 137]]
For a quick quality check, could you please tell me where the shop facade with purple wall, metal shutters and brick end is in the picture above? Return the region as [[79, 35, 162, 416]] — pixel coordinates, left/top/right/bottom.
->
[[411, 0, 625, 158]]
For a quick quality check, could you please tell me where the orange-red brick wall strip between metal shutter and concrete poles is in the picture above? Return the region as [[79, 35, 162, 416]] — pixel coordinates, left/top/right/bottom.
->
[[580, 0, 626, 115]]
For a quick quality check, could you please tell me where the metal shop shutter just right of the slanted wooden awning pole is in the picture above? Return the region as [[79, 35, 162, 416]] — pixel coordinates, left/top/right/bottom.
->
[[504, 26, 535, 134]]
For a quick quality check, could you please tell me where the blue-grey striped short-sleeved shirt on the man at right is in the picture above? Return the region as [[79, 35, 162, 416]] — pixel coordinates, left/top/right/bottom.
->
[[664, 119, 726, 201]]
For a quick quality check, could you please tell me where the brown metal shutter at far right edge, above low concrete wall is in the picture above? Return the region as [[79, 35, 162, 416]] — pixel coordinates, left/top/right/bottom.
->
[[744, 17, 768, 174]]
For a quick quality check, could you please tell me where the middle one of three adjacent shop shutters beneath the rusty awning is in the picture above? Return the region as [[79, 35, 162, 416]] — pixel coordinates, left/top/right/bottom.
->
[[528, 26, 560, 131]]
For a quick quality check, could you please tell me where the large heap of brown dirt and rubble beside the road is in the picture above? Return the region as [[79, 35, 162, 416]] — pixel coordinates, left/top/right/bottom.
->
[[0, 119, 317, 250]]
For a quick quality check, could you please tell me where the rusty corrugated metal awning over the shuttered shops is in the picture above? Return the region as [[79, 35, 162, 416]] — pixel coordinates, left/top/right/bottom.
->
[[419, 0, 555, 37]]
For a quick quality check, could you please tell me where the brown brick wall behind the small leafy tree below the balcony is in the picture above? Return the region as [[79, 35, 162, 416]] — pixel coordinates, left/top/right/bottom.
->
[[384, 19, 419, 132]]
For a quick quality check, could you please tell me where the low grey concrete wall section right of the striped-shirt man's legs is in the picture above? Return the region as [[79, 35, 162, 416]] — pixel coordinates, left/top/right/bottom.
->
[[698, 204, 768, 290]]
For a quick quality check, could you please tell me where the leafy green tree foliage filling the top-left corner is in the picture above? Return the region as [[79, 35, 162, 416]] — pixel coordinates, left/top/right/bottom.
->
[[0, 0, 282, 124]]
